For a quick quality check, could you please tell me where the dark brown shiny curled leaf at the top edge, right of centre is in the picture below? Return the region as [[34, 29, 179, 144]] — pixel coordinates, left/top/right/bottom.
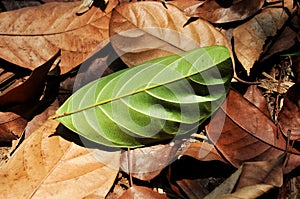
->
[[186, 0, 265, 23]]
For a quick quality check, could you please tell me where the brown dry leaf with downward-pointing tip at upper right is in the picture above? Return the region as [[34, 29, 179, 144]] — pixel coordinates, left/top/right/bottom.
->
[[233, 5, 294, 75]]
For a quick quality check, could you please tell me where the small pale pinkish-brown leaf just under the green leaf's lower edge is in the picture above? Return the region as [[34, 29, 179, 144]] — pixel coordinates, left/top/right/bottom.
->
[[121, 144, 178, 181]]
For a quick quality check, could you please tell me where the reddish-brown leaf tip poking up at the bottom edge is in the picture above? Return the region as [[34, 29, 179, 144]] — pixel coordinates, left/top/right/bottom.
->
[[119, 186, 168, 199]]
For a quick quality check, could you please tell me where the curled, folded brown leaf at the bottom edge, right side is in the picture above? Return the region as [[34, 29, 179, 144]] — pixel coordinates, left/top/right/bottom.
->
[[205, 155, 284, 199]]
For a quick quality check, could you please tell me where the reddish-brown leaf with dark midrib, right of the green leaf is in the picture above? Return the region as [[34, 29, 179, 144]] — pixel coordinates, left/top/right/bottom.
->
[[207, 91, 300, 173]]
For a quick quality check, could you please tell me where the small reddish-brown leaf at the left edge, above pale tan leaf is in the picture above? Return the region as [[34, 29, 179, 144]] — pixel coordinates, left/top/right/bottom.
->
[[0, 112, 27, 142]]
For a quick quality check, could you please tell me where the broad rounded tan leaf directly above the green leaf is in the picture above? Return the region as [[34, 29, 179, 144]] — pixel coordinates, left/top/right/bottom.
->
[[109, 1, 230, 66]]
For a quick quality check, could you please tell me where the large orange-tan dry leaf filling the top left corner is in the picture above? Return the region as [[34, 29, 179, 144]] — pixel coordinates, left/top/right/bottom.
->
[[0, 0, 117, 73]]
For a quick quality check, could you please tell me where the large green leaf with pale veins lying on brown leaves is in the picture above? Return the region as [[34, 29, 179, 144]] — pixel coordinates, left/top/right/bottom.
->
[[54, 46, 233, 147]]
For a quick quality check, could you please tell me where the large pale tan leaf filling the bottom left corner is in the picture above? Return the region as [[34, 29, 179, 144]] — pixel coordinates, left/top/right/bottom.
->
[[0, 120, 120, 198]]
